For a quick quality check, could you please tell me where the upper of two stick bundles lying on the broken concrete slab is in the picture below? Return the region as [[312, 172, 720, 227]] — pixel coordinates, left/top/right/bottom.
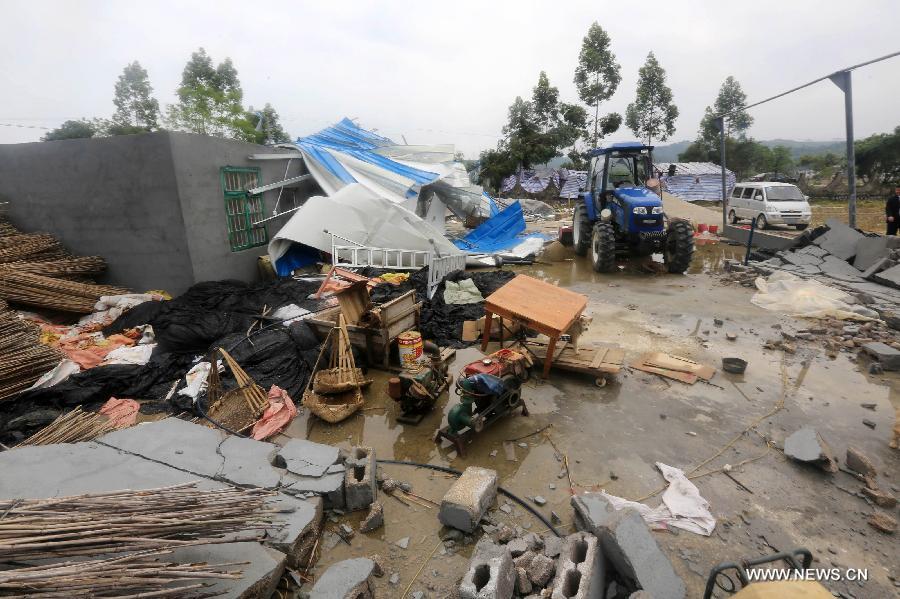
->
[[0, 483, 275, 562]]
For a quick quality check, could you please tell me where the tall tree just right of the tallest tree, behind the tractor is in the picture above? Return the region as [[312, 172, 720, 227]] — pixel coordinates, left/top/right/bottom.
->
[[625, 52, 678, 145]]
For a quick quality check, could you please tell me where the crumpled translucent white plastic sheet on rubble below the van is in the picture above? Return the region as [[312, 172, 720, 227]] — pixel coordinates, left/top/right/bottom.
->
[[750, 271, 878, 321]]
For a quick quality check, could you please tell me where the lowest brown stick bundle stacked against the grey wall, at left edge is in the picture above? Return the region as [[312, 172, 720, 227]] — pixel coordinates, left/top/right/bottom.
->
[[0, 269, 128, 314]]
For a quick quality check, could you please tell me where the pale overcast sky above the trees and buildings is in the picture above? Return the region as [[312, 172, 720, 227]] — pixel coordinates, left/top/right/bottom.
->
[[0, 0, 900, 156]]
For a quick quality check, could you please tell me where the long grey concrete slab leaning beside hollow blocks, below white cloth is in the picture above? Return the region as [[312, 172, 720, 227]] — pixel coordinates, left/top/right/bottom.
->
[[572, 493, 686, 599]]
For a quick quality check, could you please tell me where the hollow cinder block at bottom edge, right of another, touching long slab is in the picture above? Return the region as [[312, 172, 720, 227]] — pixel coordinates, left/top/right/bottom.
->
[[551, 532, 606, 599]]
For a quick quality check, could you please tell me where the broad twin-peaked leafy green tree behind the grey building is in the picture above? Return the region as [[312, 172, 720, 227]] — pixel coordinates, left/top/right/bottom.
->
[[167, 48, 252, 139]]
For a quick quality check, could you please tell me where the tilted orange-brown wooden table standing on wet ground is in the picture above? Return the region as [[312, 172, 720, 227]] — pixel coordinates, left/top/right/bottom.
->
[[481, 275, 587, 378]]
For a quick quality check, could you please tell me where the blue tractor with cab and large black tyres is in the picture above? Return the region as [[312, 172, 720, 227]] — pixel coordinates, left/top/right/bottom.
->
[[572, 142, 694, 273]]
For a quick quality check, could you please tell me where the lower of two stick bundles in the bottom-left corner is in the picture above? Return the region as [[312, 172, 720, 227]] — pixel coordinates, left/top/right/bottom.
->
[[0, 550, 249, 599]]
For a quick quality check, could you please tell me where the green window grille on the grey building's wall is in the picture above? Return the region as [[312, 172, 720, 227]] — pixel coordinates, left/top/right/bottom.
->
[[220, 166, 269, 252]]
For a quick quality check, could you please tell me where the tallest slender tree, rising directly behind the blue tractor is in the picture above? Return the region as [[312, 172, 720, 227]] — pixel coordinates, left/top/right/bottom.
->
[[575, 21, 622, 147]]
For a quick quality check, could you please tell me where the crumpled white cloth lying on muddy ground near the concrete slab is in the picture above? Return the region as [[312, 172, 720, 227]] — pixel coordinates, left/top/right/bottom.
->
[[601, 462, 716, 537]]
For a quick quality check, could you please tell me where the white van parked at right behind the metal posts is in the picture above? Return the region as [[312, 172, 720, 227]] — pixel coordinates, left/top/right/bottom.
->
[[728, 182, 812, 231]]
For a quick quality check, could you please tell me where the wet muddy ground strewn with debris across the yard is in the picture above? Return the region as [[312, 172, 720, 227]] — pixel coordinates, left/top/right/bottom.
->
[[284, 239, 900, 597]]
